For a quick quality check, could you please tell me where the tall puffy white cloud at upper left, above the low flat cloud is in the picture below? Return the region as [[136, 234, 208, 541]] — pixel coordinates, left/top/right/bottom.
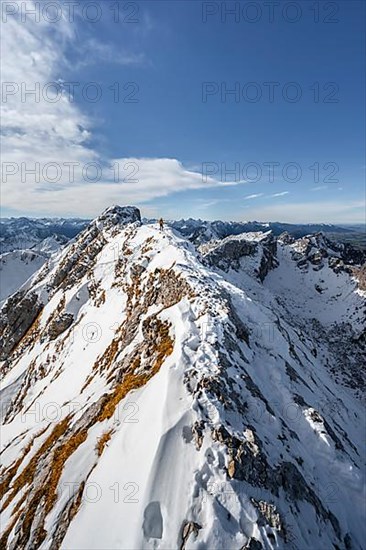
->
[[1, 2, 95, 177]]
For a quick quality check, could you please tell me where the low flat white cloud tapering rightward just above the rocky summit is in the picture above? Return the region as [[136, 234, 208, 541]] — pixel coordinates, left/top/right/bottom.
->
[[4, 158, 246, 216]]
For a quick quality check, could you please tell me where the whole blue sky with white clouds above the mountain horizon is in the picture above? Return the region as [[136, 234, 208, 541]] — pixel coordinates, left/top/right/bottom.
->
[[2, 0, 366, 223]]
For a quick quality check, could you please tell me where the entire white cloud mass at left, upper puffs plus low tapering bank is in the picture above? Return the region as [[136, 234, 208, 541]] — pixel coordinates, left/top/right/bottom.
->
[[2, 8, 246, 216]]
